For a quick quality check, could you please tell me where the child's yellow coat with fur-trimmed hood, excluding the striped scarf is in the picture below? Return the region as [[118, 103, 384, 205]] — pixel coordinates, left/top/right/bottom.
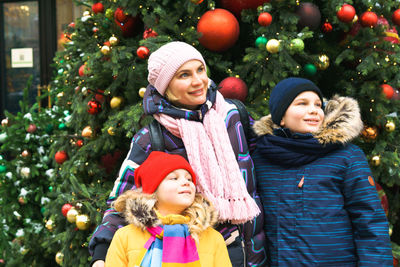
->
[[106, 189, 232, 267]]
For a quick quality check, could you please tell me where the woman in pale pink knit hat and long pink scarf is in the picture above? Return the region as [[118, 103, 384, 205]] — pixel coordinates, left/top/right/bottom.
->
[[89, 42, 266, 266]]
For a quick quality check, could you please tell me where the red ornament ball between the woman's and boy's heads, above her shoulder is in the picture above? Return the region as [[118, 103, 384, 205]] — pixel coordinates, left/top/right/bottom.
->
[[218, 77, 248, 102]]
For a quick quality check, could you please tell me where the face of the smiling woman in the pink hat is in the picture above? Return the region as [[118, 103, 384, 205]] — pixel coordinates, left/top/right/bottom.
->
[[165, 59, 208, 110]]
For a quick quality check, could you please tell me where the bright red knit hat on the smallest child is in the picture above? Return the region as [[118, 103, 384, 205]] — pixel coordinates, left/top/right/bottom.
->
[[134, 151, 196, 194]]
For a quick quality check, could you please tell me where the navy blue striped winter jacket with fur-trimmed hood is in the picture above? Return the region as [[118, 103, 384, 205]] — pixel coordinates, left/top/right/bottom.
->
[[252, 97, 393, 267]]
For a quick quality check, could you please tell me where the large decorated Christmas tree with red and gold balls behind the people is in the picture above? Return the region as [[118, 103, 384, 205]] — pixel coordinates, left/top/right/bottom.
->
[[46, 0, 400, 266]]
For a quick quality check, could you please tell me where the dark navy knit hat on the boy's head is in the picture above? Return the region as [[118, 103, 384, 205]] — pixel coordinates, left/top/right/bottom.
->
[[269, 77, 323, 125]]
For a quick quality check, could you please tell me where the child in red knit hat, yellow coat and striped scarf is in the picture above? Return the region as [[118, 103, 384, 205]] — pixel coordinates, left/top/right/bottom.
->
[[106, 151, 232, 267]]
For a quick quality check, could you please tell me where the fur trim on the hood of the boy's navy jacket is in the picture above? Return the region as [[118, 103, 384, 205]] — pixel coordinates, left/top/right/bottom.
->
[[253, 95, 363, 144]]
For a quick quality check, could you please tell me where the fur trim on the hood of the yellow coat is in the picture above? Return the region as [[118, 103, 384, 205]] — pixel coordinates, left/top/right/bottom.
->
[[114, 189, 218, 240]]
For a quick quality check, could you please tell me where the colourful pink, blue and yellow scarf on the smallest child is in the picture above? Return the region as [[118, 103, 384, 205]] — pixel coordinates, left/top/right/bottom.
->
[[134, 212, 201, 267]]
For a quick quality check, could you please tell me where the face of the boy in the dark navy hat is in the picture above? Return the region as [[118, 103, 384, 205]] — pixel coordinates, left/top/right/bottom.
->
[[281, 91, 325, 133]]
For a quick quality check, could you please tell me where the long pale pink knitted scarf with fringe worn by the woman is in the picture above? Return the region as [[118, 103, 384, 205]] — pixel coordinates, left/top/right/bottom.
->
[[153, 92, 260, 224]]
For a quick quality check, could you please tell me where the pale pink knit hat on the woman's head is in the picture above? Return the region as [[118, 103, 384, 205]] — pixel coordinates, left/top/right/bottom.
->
[[147, 42, 206, 96]]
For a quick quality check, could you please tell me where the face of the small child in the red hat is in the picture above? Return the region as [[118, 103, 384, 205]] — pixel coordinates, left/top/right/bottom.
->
[[156, 169, 196, 216]]
